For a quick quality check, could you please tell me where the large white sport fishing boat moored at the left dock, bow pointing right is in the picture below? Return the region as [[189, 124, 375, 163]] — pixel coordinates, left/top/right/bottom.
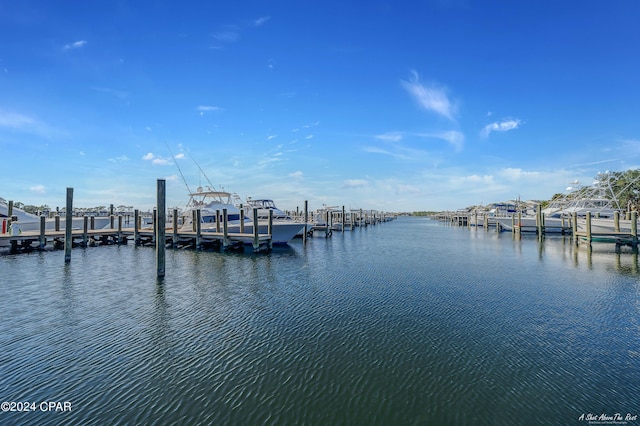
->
[[181, 187, 304, 244]]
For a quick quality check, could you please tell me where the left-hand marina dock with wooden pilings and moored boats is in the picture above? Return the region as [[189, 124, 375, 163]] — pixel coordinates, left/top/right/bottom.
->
[[0, 183, 391, 259]]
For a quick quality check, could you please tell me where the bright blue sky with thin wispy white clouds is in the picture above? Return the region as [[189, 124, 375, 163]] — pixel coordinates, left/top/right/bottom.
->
[[0, 0, 640, 211]]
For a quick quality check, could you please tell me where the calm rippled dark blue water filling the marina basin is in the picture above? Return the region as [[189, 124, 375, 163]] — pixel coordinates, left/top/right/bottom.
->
[[0, 218, 640, 425]]
